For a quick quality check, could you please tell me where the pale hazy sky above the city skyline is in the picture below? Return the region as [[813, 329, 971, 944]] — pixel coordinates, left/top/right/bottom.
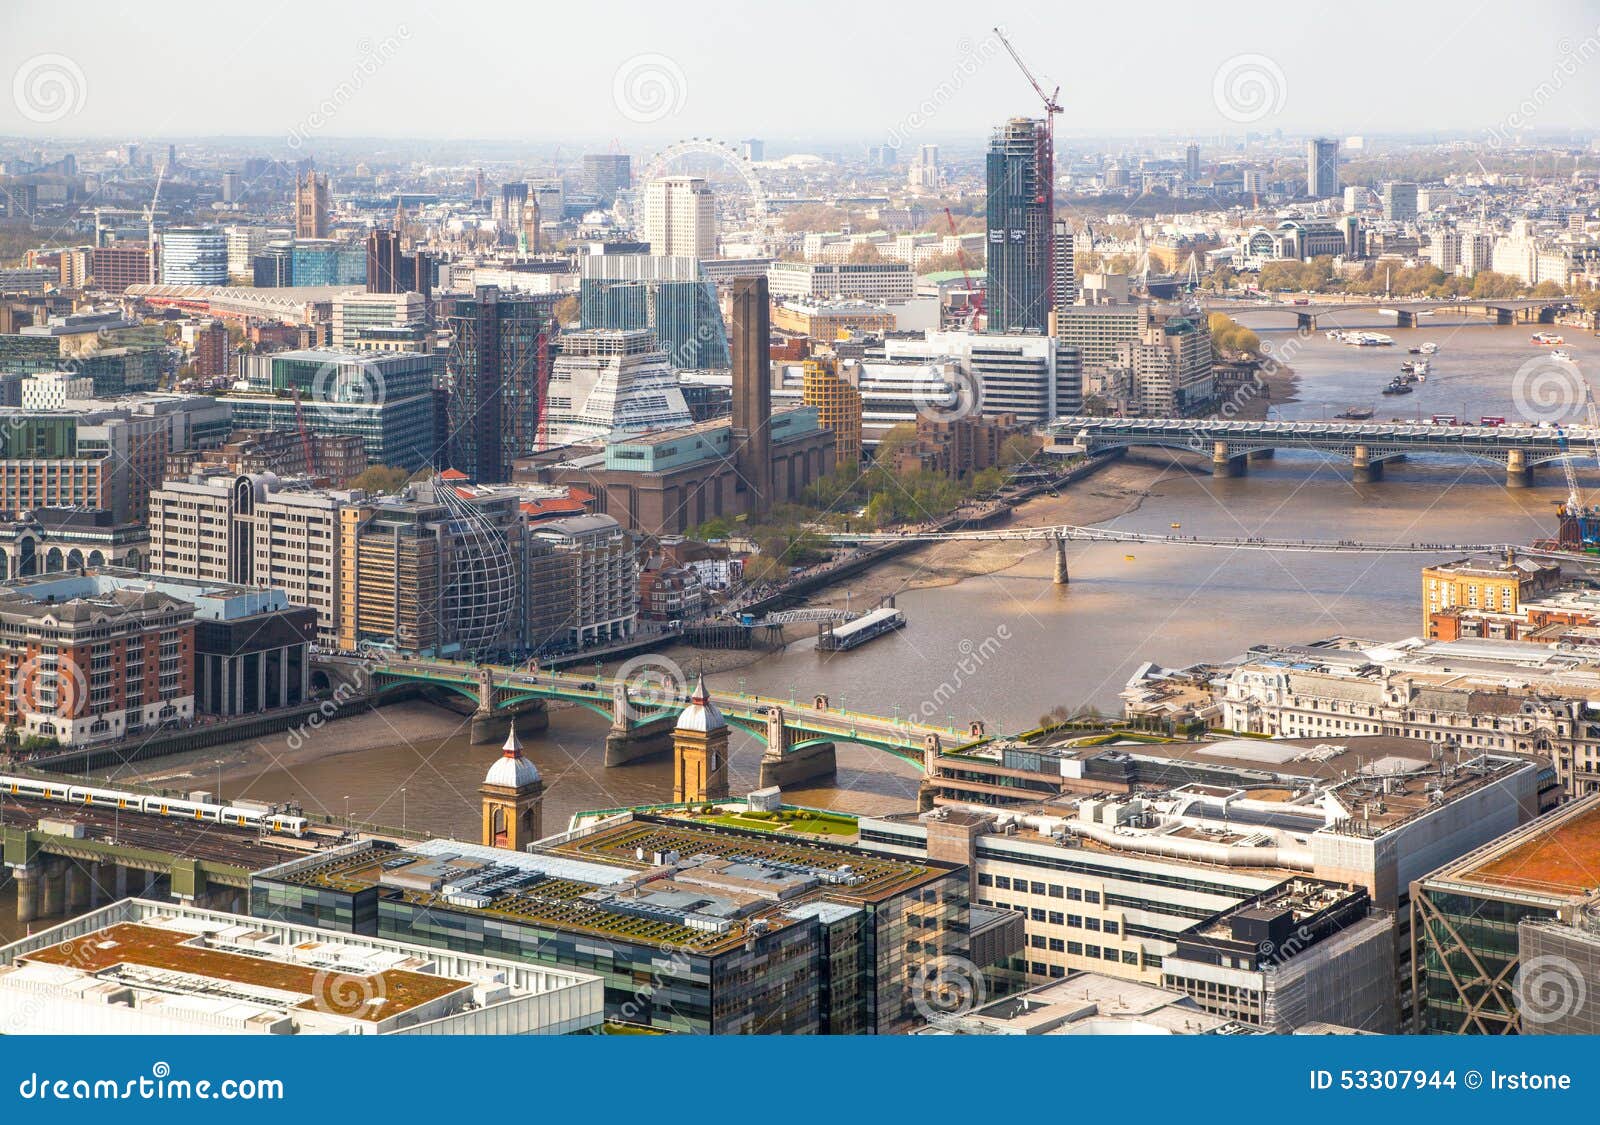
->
[[0, 0, 1600, 147]]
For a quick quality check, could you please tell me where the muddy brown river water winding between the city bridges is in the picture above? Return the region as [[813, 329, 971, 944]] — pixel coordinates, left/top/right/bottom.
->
[[118, 314, 1600, 837]]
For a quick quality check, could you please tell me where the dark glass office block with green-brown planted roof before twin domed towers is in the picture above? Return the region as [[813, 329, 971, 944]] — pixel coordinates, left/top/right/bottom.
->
[[251, 813, 970, 1034]]
